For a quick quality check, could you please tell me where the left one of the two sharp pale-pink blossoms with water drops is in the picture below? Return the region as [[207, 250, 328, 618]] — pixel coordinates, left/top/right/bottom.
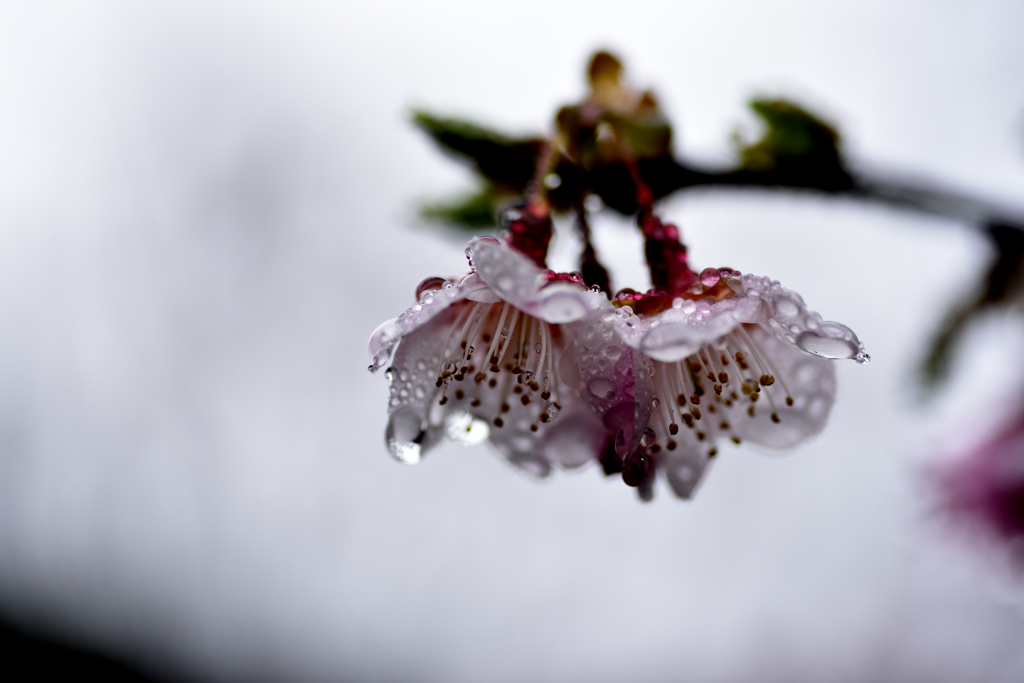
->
[[370, 238, 607, 476]]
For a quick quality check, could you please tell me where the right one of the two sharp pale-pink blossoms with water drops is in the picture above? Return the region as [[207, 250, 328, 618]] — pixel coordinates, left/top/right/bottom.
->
[[574, 264, 869, 500]]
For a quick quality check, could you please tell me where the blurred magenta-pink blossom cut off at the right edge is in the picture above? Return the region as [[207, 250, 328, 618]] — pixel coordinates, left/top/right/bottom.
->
[[934, 419, 1024, 571]]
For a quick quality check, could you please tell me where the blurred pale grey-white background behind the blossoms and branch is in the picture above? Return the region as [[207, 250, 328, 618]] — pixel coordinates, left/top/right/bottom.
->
[[0, 0, 1024, 682]]
